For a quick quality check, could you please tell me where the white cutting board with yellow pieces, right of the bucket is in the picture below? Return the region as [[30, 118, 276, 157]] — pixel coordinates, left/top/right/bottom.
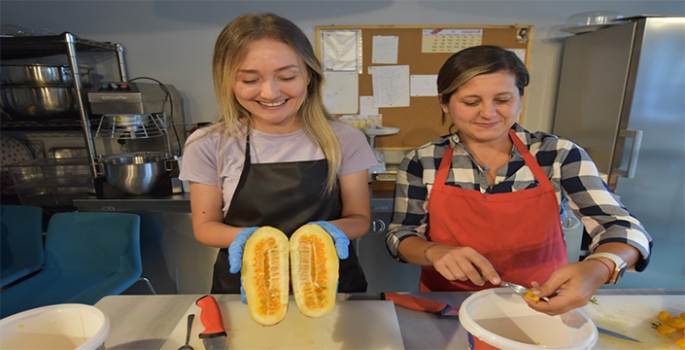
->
[[584, 295, 685, 350]]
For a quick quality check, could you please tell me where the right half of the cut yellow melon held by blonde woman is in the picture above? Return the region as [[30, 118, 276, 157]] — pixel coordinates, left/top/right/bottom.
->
[[290, 225, 338, 318]]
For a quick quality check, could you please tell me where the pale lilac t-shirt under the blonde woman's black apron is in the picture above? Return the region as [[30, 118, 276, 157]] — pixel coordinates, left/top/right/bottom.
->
[[179, 121, 378, 214]]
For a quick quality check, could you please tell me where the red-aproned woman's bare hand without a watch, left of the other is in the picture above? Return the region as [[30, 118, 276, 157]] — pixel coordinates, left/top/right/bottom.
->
[[424, 243, 500, 286]]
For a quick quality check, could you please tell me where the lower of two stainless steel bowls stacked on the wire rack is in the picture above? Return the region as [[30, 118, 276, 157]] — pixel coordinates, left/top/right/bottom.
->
[[0, 85, 78, 119]]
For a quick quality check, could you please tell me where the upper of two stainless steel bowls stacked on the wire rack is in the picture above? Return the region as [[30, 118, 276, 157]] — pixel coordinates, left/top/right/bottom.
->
[[0, 64, 93, 87]]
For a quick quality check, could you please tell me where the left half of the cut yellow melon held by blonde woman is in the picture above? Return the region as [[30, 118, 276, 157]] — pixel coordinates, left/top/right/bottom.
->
[[241, 226, 290, 326]]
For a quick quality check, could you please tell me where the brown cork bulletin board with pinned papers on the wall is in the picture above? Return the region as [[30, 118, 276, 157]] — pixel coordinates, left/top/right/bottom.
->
[[316, 24, 533, 150]]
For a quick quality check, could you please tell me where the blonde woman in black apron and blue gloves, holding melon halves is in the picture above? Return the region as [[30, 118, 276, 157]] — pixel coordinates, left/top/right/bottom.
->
[[180, 14, 377, 294]]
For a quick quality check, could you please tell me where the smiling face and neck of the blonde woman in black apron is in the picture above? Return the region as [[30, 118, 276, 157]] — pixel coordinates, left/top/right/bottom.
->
[[233, 39, 309, 134]]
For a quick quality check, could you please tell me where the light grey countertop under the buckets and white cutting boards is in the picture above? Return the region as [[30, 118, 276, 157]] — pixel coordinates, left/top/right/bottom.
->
[[95, 289, 685, 349]]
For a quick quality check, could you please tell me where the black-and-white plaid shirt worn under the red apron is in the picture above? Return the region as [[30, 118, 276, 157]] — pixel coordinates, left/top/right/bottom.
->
[[386, 124, 652, 271]]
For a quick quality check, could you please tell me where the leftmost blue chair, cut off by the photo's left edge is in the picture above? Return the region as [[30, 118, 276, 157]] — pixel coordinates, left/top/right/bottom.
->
[[0, 205, 44, 288]]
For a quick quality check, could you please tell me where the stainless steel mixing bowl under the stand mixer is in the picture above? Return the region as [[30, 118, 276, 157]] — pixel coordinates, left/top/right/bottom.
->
[[102, 152, 167, 194]]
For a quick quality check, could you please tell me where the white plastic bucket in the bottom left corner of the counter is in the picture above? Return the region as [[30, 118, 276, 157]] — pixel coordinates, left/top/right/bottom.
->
[[0, 304, 109, 350]]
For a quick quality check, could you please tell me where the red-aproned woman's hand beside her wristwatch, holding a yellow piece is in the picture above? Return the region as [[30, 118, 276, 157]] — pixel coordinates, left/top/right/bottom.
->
[[523, 260, 610, 316]]
